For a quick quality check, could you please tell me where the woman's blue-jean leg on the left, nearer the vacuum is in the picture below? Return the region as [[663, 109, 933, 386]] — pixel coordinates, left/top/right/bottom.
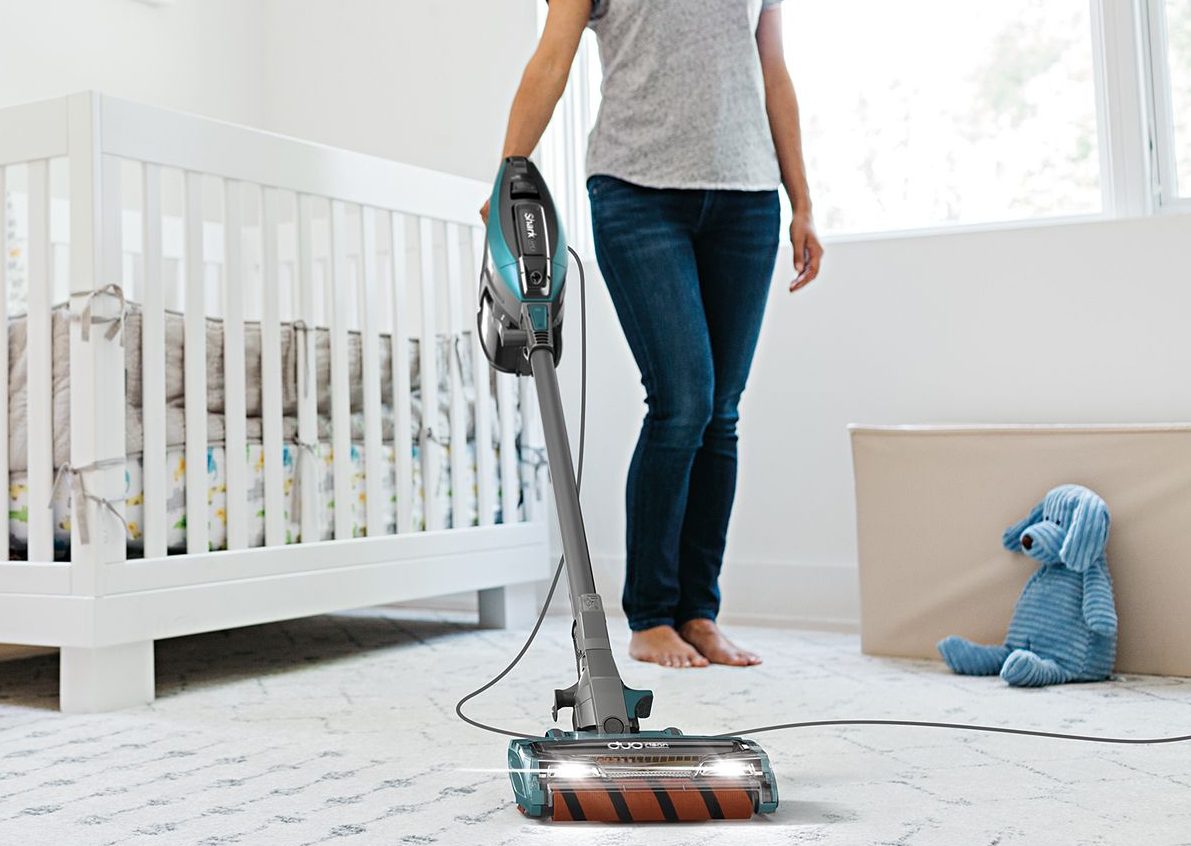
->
[[590, 178, 713, 648]]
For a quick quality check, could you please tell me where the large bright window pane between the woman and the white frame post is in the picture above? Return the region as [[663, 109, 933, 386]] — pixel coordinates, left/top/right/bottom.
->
[[782, 0, 1100, 232]]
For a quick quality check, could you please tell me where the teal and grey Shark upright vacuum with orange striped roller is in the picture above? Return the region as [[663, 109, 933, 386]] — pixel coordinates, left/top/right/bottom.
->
[[474, 156, 778, 822]]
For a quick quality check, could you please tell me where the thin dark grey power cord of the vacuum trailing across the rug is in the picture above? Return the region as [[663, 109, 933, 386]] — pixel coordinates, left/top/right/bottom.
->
[[455, 247, 1191, 746]]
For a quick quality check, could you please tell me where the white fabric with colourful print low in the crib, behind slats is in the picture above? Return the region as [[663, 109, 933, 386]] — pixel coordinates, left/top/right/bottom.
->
[[8, 441, 522, 560]]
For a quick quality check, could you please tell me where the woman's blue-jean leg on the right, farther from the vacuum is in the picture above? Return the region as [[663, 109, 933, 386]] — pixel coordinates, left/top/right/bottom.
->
[[675, 191, 780, 643]]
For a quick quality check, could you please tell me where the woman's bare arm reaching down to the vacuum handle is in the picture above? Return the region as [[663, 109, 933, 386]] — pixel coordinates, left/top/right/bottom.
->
[[480, 0, 592, 222]]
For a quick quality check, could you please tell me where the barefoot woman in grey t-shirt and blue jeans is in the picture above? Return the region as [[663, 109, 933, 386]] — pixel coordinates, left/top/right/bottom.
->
[[484, 0, 823, 667]]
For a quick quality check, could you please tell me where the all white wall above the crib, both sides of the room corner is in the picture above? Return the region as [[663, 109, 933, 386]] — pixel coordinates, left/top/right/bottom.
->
[[0, 0, 537, 180]]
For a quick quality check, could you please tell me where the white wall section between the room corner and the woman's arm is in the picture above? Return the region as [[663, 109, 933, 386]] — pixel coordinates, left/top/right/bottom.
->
[[263, 0, 537, 180]]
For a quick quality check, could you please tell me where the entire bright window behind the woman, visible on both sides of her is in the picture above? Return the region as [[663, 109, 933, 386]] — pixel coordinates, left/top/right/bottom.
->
[[543, 0, 1191, 243]]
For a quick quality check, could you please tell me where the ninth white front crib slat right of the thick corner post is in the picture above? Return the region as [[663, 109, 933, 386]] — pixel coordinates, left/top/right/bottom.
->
[[419, 218, 448, 529]]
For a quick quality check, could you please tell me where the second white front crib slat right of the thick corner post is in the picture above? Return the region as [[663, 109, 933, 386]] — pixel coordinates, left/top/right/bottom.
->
[[183, 172, 210, 553]]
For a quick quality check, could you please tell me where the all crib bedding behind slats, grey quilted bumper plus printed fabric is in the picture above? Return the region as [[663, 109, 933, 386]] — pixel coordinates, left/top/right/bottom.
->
[[8, 303, 533, 560]]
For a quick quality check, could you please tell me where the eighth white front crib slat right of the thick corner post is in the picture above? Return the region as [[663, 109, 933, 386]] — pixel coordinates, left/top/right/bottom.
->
[[389, 212, 413, 533]]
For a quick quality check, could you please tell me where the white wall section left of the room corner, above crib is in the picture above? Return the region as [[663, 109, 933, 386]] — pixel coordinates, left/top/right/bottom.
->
[[0, 0, 263, 124]]
